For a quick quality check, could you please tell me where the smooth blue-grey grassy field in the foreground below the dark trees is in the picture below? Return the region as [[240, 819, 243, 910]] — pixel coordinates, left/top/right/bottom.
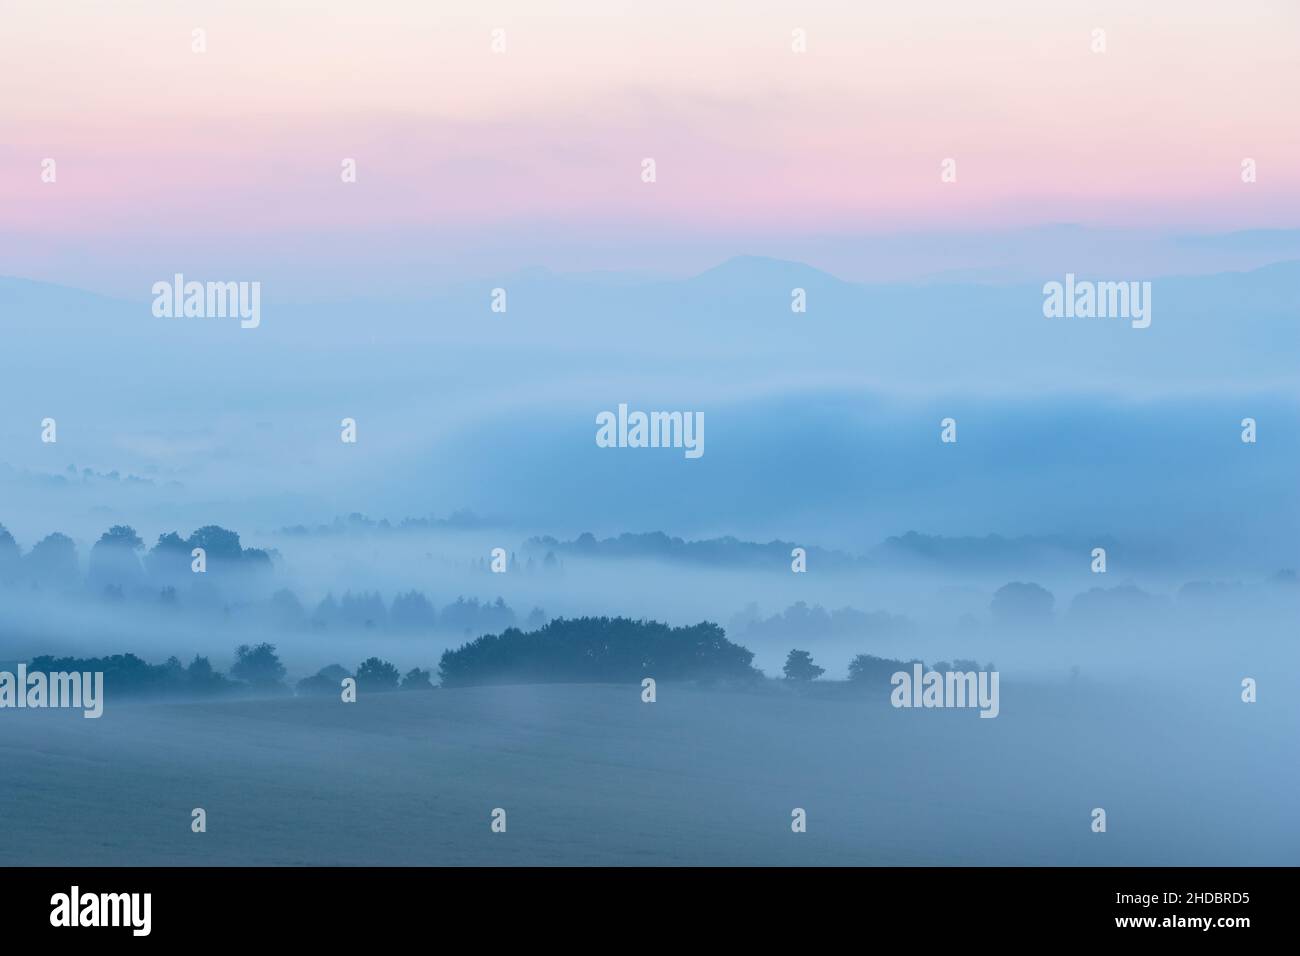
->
[[0, 684, 1300, 865]]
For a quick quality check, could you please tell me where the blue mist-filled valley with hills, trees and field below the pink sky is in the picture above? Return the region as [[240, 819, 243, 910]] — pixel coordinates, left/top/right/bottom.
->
[[0, 259, 1300, 864]]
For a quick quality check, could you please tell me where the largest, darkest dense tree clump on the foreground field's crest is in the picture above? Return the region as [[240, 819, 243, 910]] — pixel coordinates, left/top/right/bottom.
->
[[438, 618, 762, 687]]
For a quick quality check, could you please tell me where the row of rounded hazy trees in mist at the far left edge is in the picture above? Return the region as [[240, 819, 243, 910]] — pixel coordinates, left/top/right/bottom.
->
[[0, 524, 273, 596]]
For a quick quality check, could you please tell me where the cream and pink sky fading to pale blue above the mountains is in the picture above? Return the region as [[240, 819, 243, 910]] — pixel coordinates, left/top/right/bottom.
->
[[0, 0, 1300, 290]]
